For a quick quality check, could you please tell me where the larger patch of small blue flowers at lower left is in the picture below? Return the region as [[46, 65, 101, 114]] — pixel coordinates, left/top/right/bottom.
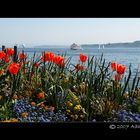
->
[[13, 99, 67, 122]]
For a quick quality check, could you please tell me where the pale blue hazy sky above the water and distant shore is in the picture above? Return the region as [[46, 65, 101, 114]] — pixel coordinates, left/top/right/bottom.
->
[[0, 18, 140, 45]]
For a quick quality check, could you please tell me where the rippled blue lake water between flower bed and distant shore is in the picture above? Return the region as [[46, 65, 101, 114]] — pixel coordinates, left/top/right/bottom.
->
[[1, 46, 140, 80]]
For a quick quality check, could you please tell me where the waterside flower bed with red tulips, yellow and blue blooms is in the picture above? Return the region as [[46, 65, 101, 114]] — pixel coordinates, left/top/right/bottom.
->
[[0, 48, 140, 122]]
